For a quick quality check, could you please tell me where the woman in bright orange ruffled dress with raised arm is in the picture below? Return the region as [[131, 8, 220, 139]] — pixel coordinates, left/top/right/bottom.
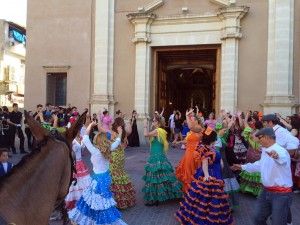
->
[[176, 111, 202, 192]]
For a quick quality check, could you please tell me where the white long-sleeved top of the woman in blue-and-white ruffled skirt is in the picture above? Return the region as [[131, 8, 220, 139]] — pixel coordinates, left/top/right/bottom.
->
[[82, 135, 121, 174]]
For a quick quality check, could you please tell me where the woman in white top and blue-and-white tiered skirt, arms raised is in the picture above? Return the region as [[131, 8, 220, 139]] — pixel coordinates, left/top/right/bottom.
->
[[68, 122, 126, 225]]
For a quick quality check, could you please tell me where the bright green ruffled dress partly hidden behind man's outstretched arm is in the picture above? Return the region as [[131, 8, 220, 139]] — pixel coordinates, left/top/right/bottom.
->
[[239, 127, 262, 196]]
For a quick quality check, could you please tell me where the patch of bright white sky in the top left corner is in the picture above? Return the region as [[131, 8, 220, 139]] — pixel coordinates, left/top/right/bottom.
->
[[0, 0, 27, 27]]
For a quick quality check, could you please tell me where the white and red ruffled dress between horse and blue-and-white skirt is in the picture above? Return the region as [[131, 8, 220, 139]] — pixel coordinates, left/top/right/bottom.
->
[[65, 139, 91, 210]]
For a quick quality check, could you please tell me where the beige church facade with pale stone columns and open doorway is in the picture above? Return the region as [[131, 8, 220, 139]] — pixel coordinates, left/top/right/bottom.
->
[[25, 0, 300, 117]]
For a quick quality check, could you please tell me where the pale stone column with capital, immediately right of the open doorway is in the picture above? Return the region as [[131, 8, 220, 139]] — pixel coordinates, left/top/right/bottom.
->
[[218, 6, 249, 112]]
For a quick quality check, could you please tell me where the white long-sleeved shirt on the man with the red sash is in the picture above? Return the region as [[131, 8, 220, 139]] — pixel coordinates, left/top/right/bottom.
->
[[242, 143, 293, 187]]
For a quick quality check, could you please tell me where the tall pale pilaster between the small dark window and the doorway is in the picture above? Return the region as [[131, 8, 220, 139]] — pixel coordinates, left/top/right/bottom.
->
[[91, 0, 115, 115]]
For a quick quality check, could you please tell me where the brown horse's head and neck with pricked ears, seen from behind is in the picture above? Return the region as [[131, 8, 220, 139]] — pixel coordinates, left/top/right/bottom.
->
[[0, 112, 86, 225]]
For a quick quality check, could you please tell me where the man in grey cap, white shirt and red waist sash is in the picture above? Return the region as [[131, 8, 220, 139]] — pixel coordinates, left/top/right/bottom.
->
[[232, 128, 293, 225]]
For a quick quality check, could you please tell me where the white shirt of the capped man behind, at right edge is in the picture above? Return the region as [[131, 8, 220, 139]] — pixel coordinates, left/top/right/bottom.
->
[[273, 124, 299, 150]]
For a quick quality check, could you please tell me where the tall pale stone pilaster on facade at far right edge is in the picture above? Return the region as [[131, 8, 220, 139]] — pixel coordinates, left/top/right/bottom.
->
[[263, 0, 295, 115]]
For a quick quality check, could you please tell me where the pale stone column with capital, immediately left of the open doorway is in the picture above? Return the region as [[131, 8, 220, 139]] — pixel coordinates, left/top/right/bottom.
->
[[127, 13, 156, 145]]
